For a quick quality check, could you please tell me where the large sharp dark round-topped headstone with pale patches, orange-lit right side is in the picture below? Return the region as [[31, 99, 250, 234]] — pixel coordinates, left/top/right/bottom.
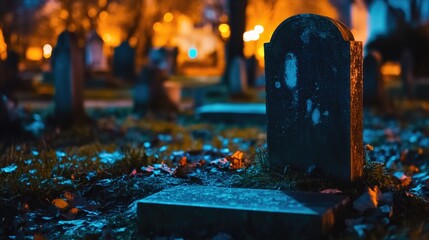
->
[[265, 14, 363, 180]]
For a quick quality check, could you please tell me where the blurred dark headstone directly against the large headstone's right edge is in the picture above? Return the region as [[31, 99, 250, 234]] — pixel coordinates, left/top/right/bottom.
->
[[363, 51, 384, 107]]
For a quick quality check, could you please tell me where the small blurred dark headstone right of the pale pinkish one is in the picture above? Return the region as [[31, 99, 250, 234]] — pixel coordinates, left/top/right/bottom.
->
[[113, 41, 135, 82]]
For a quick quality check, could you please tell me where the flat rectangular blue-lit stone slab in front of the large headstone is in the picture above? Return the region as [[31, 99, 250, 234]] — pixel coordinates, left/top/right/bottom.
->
[[137, 186, 350, 239]]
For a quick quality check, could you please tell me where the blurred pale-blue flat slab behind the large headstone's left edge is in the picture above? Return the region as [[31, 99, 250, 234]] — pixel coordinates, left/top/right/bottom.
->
[[195, 103, 267, 124]]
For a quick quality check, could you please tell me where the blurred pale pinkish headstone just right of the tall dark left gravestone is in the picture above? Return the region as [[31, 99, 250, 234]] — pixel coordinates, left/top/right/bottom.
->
[[85, 31, 108, 72]]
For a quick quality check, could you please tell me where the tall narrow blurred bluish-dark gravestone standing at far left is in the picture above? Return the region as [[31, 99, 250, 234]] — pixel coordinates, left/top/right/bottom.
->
[[52, 31, 85, 122]]
